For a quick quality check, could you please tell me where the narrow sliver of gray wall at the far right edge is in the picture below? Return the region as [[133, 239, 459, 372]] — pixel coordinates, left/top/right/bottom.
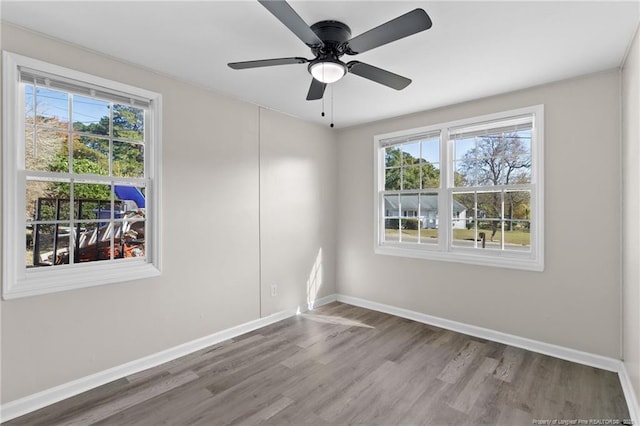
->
[[622, 25, 640, 404]]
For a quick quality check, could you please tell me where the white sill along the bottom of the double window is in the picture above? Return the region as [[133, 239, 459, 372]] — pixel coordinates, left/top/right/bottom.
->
[[374, 245, 544, 272]]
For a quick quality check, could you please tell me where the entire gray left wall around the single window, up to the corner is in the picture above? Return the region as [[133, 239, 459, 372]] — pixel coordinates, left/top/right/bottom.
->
[[0, 24, 336, 402]]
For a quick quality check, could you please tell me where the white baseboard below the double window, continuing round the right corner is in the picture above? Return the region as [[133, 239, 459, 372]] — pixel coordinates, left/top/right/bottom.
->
[[337, 294, 640, 424]]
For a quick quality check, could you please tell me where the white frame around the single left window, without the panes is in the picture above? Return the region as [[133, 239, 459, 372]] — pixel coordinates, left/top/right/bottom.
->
[[2, 51, 162, 300]]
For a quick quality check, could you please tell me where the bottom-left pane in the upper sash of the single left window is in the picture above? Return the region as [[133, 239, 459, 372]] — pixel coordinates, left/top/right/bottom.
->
[[25, 126, 69, 173]]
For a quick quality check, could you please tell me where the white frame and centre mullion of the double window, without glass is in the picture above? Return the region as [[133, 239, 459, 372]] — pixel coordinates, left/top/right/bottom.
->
[[374, 105, 544, 271]]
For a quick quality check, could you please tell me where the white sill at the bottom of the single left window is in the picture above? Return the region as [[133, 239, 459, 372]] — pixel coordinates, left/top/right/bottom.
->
[[2, 260, 160, 300]]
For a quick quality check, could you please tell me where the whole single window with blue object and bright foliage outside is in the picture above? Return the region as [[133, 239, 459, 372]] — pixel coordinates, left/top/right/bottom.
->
[[2, 52, 161, 299]]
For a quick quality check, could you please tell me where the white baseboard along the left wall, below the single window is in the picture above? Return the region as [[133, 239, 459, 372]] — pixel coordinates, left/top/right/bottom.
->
[[0, 294, 336, 422]]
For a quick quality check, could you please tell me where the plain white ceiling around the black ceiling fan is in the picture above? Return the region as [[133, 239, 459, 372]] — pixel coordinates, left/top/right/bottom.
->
[[0, 0, 640, 127]]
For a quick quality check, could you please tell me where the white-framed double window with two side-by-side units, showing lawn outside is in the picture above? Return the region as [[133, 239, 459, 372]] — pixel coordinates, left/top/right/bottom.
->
[[375, 105, 544, 271]]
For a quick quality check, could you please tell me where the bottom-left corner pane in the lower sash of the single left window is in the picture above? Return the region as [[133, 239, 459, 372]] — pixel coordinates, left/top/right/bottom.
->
[[31, 223, 71, 267]]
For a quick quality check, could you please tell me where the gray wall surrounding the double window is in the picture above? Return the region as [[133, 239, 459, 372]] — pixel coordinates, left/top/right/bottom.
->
[[337, 71, 621, 358]]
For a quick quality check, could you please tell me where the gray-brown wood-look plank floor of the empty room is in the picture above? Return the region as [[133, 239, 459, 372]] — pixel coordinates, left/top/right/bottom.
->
[[7, 302, 629, 426]]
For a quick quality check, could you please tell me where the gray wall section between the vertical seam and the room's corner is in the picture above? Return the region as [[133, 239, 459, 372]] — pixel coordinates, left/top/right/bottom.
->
[[260, 110, 337, 315]]
